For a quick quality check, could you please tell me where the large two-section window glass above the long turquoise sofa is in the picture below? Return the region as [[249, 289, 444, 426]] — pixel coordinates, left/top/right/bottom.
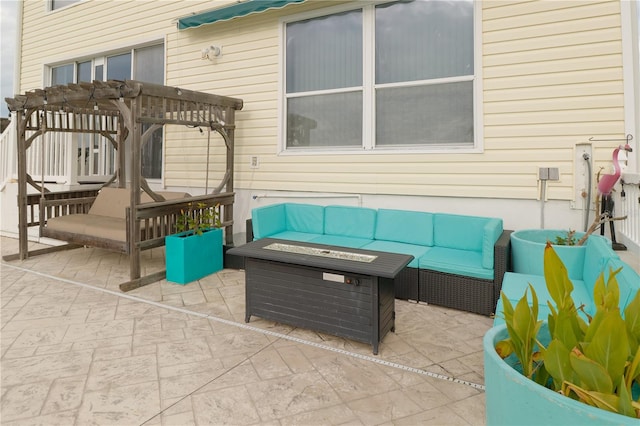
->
[[283, 0, 475, 150]]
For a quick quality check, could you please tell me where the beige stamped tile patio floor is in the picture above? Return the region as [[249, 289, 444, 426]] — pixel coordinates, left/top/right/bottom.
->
[[0, 237, 636, 426]]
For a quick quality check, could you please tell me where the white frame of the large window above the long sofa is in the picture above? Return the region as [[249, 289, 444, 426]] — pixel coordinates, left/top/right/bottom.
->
[[277, 0, 484, 155]]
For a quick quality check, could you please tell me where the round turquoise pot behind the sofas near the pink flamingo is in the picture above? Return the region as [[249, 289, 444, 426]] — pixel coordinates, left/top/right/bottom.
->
[[511, 229, 603, 280]]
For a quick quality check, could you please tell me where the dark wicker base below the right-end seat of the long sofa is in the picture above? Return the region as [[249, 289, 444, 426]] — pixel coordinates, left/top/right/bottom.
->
[[418, 269, 495, 315]]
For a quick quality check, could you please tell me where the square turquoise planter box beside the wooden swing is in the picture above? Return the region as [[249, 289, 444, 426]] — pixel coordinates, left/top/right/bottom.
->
[[165, 228, 223, 284]]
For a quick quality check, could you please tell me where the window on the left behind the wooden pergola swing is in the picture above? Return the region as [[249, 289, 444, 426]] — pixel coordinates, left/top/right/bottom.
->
[[50, 44, 164, 179]]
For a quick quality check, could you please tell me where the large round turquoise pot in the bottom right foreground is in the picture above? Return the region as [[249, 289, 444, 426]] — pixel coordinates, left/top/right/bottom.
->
[[483, 324, 639, 426]]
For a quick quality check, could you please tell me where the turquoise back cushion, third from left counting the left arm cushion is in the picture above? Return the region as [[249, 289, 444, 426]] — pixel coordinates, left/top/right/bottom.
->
[[324, 206, 376, 240]]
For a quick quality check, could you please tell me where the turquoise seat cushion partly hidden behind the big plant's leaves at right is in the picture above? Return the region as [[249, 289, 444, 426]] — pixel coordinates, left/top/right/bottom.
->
[[502, 272, 595, 320]]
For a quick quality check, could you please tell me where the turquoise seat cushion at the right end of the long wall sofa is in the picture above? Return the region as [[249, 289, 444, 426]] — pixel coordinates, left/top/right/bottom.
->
[[418, 247, 493, 280]]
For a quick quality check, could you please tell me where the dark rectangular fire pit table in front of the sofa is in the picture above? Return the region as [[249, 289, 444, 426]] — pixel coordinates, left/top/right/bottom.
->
[[228, 238, 413, 355]]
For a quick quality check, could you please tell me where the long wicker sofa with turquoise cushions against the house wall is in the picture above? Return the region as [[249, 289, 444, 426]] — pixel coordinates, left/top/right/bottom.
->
[[247, 203, 510, 315]]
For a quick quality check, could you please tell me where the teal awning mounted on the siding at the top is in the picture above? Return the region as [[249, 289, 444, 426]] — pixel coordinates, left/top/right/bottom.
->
[[178, 0, 305, 30]]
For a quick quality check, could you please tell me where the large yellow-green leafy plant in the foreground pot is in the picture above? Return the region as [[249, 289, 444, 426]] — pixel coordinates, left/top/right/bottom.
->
[[496, 243, 640, 418]]
